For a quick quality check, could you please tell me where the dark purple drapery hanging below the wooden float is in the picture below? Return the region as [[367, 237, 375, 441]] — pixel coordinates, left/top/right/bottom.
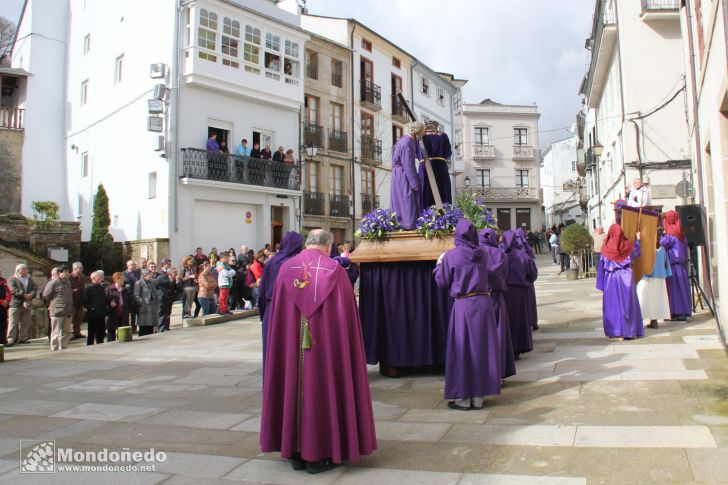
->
[[359, 261, 452, 367]]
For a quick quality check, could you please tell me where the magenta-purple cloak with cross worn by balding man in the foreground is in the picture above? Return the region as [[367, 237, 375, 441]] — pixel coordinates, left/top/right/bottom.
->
[[260, 249, 377, 463]]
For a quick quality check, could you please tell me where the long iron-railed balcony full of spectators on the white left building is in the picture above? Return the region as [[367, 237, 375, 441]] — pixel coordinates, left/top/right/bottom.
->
[[182, 148, 301, 191]]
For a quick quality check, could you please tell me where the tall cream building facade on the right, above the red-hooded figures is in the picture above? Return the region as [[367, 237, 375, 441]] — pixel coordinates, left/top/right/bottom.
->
[[579, 0, 691, 229]]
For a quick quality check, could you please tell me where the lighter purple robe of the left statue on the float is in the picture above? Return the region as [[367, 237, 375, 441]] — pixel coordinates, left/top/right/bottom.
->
[[389, 135, 422, 230]]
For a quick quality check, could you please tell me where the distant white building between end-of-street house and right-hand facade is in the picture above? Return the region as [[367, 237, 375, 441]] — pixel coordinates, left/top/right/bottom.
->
[[541, 136, 584, 227]]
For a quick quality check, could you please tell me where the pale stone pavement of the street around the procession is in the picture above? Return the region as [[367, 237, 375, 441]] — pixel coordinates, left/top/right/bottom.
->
[[0, 253, 728, 485]]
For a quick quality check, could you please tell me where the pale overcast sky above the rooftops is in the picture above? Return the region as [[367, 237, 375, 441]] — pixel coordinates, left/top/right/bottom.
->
[[0, 0, 594, 148]]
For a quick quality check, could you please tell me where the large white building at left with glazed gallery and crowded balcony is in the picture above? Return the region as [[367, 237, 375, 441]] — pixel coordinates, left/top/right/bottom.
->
[[14, 0, 308, 261]]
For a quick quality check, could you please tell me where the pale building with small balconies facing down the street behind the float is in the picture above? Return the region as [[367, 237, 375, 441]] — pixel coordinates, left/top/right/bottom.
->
[[456, 99, 544, 231]]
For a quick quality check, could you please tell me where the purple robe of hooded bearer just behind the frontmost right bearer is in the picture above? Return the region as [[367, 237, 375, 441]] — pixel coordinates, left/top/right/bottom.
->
[[478, 228, 516, 378]]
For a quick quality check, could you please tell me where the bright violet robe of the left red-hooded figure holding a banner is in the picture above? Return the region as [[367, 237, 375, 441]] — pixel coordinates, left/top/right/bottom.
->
[[597, 241, 645, 338]]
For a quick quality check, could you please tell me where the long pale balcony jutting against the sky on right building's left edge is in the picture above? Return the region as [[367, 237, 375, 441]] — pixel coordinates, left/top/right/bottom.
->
[[580, 0, 617, 108]]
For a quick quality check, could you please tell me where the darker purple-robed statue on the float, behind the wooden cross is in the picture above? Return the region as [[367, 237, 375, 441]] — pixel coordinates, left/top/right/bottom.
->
[[417, 123, 452, 208]]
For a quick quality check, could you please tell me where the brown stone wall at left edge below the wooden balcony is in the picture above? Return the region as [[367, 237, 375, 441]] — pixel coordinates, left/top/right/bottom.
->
[[0, 129, 24, 214]]
